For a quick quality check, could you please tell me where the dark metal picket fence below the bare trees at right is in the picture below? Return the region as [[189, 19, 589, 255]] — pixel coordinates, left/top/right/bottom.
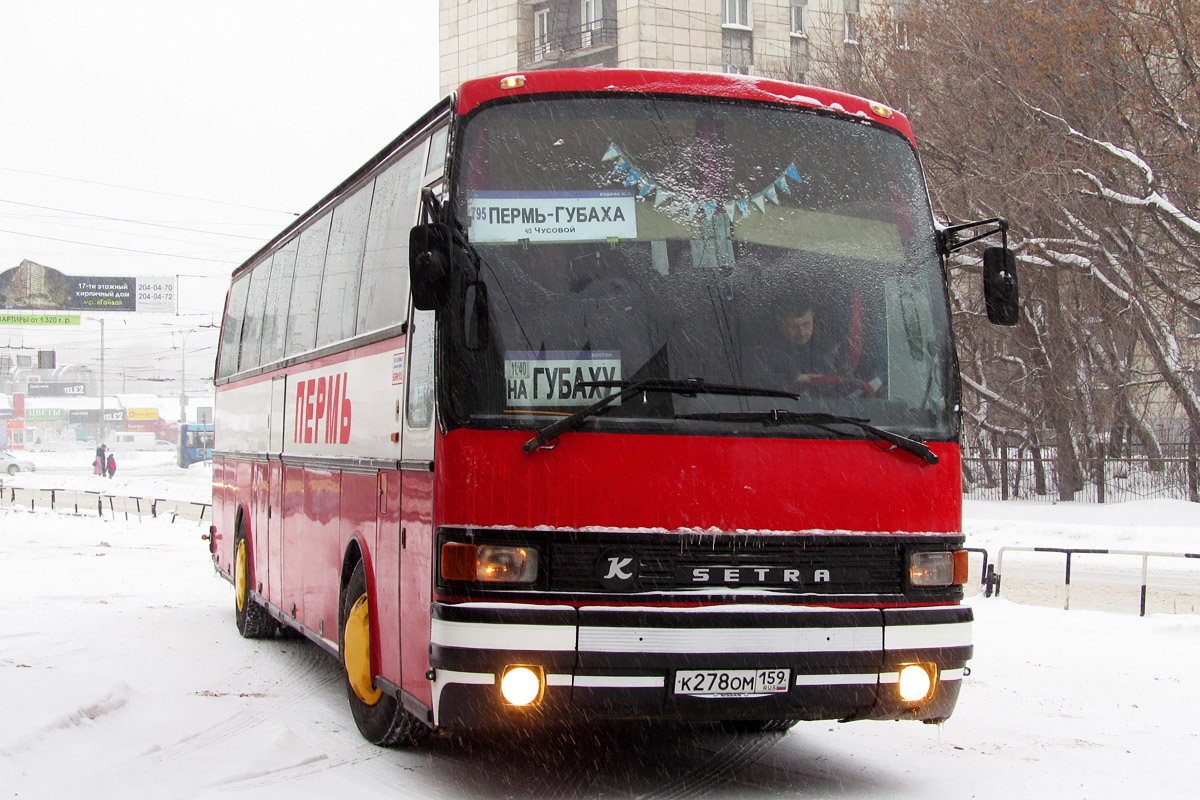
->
[[962, 443, 1200, 503]]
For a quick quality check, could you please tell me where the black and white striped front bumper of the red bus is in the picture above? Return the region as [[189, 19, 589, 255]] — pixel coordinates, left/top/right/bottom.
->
[[430, 603, 972, 727]]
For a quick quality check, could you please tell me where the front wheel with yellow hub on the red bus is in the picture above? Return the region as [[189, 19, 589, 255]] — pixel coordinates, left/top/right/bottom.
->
[[338, 561, 431, 747]]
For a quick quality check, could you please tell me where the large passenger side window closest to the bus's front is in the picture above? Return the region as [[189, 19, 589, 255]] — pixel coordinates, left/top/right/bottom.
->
[[359, 145, 425, 333]]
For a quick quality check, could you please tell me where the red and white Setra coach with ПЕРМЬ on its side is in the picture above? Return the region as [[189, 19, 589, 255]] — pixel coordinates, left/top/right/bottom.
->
[[210, 70, 1016, 745]]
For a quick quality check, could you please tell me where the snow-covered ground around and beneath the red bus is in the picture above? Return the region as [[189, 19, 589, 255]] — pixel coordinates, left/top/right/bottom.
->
[[0, 453, 1200, 800]]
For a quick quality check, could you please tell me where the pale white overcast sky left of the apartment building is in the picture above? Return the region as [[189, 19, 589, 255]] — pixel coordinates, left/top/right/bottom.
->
[[0, 0, 438, 395]]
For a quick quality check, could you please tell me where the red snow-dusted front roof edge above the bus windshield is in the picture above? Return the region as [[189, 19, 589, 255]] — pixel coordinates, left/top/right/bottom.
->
[[456, 68, 916, 146]]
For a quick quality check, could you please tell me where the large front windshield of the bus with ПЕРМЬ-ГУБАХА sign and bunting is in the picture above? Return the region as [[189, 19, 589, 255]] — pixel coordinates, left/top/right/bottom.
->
[[443, 96, 958, 439]]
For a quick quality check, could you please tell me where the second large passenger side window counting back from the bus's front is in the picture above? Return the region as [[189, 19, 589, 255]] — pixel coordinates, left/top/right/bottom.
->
[[317, 181, 374, 347]]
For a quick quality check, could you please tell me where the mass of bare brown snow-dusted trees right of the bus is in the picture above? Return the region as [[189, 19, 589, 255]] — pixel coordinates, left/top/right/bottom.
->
[[811, 0, 1200, 497]]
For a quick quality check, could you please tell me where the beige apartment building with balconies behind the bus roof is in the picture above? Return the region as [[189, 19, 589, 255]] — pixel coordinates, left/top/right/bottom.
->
[[439, 0, 901, 94]]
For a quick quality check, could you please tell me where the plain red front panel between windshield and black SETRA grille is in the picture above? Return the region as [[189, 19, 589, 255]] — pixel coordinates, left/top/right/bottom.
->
[[437, 429, 962, 534]]
